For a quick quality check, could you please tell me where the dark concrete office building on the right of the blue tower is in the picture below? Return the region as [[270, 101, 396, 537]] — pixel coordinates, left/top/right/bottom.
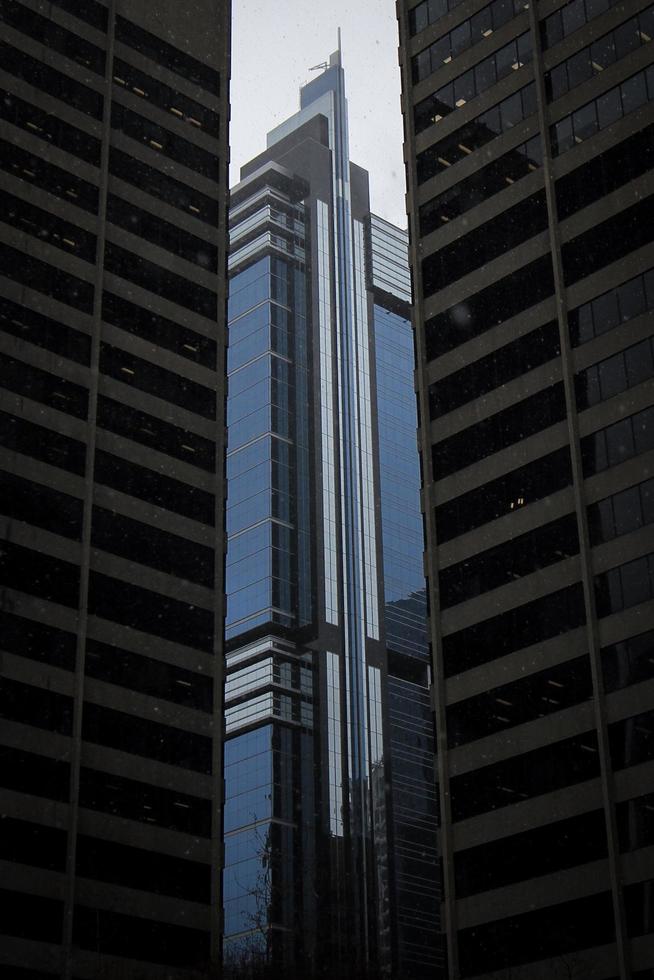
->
[[398, 0, 654, 980]]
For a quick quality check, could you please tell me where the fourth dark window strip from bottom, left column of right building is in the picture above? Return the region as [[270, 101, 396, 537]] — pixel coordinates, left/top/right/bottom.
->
[[447, 655, 593, 748]]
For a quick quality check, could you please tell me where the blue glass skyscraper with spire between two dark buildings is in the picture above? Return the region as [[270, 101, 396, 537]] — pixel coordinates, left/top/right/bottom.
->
[[224, 52, 440, 980]]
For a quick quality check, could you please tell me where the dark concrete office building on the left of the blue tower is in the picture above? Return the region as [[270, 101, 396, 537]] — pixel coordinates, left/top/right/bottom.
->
[[0, 0, 229, 980]]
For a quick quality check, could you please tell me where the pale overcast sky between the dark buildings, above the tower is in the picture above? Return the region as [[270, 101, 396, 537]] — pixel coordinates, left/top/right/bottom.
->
[[230, 0, 406, 228]]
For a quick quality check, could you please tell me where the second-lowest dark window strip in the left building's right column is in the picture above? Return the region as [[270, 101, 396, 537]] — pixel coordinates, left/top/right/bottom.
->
[[76, 836, 211, 904]]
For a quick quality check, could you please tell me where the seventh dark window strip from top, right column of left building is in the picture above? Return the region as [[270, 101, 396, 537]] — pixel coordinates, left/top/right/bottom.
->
[[102, 292, 216, 370]]
